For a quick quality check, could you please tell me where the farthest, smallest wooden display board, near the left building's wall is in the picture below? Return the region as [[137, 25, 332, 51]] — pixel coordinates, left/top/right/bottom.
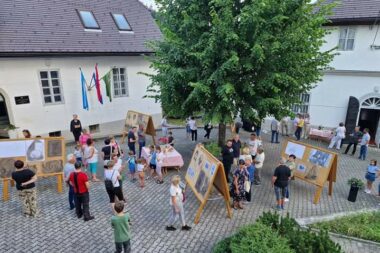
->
[[122, 111, 156, 144]]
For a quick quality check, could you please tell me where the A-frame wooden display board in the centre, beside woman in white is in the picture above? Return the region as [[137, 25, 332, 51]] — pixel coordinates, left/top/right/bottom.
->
[[185, 144, 232, 224]]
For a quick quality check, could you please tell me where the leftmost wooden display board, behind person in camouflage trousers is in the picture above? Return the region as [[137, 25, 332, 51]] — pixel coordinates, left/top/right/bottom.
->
[[0, 137, 65, 200]]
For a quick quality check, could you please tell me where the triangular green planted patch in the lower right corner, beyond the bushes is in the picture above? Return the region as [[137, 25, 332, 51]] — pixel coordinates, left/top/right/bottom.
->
[[310, 212, 380, 243]]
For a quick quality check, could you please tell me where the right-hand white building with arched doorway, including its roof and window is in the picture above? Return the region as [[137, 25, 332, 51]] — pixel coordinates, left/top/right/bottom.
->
[[290, 0, 380, 145]]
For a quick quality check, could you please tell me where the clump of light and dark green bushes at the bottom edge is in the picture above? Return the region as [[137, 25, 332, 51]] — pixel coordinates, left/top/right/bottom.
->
[[214, 212, 342, 253]]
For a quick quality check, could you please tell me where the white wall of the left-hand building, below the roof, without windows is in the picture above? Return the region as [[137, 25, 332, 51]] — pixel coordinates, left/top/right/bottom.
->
[[0, 56, 161, 138]]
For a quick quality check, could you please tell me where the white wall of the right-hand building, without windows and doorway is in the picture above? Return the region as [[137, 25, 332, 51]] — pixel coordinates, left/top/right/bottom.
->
[[309, 25, 380, 127]]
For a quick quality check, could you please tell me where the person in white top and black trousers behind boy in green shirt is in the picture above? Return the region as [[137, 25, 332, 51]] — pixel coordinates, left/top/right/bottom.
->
[[104, 160, 124, 210]]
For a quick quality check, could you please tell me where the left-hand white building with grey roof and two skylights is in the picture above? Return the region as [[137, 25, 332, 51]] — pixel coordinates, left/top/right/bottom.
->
[[0, 0, 162, 139]]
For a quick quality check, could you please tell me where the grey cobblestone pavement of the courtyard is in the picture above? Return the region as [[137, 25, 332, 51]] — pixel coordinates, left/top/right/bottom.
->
[[0, 129, 380, 253]]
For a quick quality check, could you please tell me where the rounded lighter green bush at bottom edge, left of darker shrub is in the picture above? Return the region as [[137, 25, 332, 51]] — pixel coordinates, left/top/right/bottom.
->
[[213, 223, 294, 253]]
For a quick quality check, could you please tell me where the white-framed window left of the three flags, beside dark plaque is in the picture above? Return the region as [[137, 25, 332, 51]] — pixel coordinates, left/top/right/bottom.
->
[[40, 70, 63, 104]]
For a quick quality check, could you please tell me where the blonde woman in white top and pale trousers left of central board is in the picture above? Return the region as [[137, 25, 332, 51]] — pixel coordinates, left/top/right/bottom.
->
[[166, 175, 191, 231]]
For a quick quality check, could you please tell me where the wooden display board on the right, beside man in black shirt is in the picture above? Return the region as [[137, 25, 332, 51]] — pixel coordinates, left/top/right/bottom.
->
[[281, 140, 338, 204]]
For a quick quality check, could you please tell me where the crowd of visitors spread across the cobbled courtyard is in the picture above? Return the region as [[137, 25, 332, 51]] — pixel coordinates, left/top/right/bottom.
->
[[6, 115, 380, 252]]
